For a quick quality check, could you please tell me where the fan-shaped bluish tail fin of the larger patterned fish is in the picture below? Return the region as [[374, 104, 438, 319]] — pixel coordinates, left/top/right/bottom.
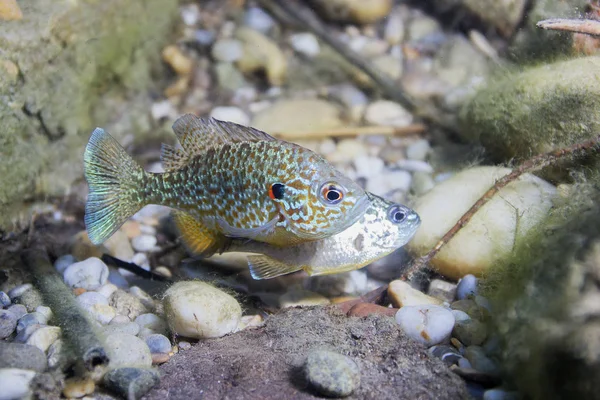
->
[[83, 128, 146, 245]]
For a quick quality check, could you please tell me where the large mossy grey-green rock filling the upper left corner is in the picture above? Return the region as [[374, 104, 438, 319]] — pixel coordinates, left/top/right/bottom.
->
[[0, 0, 178, 227]]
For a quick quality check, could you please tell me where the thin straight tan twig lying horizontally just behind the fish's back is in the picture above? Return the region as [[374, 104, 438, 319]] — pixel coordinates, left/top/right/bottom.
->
[[271, 124, 426, 140]]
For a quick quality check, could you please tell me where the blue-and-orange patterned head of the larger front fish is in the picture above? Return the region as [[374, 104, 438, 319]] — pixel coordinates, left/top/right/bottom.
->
[[271, 155, 369, 241]]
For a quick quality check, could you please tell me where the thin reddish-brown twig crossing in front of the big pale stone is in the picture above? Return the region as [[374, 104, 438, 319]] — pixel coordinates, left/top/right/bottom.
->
[[401, 136, 600, 281]]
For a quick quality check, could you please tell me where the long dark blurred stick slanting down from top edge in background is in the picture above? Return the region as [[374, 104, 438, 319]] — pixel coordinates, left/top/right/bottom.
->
[[258, 0, 456, 132]]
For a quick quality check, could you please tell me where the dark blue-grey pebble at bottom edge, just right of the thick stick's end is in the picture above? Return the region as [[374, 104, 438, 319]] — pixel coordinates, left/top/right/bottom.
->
[[103, 367, 160, 399]]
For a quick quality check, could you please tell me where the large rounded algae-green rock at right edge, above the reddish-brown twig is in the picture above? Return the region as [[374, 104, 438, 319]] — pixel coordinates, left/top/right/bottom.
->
[[460, 57, 600, 160]]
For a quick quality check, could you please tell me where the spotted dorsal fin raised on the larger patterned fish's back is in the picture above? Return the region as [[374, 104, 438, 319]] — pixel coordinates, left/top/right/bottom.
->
[[173, 114, 277, 156]]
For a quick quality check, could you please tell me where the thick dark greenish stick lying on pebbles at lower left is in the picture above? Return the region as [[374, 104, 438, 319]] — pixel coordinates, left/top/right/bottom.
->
[[21, 247, 109, 371]]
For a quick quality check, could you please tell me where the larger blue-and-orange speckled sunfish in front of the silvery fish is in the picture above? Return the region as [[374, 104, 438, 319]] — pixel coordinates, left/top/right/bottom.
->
[[84, 114, 369, 256]]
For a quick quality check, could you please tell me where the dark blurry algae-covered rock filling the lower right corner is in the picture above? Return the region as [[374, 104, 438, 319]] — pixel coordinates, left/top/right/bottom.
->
[[483, 176, 600, 399]]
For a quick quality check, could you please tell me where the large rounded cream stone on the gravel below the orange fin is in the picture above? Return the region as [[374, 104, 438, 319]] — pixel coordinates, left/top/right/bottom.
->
[[164, 281, 242, 339]]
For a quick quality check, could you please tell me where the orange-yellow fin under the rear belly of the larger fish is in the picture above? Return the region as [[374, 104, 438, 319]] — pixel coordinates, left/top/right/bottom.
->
[[173, 211, 229, 257]]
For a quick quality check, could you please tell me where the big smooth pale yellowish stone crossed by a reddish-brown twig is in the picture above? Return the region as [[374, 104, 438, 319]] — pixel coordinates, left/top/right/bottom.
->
[[407, 167, 556, 279]]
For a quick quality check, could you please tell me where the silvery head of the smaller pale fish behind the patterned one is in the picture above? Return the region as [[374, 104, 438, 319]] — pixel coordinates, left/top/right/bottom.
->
[[359, 193, 421, 250]]
